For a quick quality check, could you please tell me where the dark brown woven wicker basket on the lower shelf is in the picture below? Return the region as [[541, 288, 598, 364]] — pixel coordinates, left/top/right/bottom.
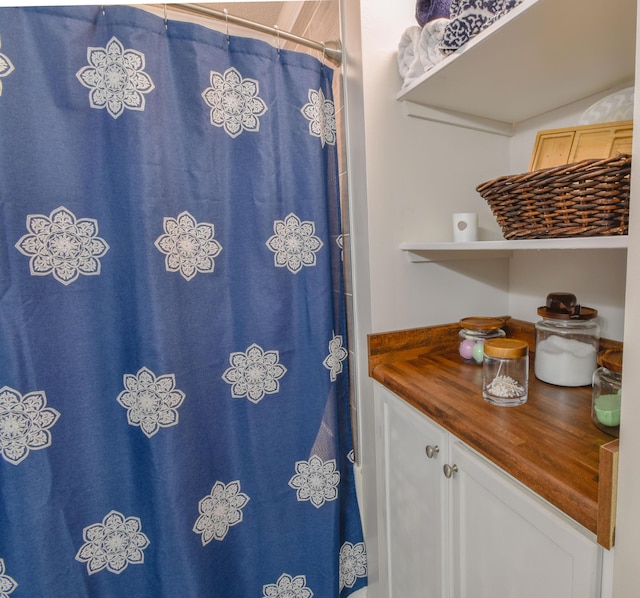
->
[[477, 154, 631, 239]]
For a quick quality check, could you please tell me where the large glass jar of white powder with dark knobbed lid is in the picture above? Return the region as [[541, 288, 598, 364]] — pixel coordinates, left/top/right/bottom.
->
[[534, 293, 600, 386]]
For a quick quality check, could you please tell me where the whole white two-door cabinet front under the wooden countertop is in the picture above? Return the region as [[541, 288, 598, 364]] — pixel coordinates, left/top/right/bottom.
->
[[375, 384, 602, 598]]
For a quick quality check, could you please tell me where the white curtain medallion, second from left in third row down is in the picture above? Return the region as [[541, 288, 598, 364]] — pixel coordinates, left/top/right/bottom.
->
[[116, 367, 185, 438]]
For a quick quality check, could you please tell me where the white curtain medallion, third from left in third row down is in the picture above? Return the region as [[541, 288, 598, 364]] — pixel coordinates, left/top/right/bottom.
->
[[222, 343, 287, 404]]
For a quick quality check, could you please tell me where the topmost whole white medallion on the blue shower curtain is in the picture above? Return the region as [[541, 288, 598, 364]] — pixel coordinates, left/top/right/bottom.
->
[[76, 37, 155, 118]]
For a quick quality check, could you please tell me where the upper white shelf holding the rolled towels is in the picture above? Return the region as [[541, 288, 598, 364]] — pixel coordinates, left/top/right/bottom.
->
[[397, 0, 636, 134]]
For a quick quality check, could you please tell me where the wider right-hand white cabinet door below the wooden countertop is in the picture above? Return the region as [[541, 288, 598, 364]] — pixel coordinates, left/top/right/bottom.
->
[[450, 438, 602, 598]]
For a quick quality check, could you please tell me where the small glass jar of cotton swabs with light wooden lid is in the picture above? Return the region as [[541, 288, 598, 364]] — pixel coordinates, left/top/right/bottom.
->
[[482, 338, 529, 407]]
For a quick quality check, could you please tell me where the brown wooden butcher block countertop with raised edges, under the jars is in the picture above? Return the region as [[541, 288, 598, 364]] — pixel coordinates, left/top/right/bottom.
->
[[369, 320, 621, 548]]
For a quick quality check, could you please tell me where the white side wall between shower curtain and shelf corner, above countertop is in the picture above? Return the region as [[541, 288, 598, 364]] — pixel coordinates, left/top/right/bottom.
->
[[361, 0, 509, 332]]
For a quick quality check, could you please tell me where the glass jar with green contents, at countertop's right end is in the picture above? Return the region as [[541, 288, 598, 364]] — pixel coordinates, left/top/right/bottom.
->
[[591, 350, 622, 438]]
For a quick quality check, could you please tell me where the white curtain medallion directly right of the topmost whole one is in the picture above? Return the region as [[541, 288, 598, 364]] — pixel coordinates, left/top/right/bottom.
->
[[201, 67, 267, 138]]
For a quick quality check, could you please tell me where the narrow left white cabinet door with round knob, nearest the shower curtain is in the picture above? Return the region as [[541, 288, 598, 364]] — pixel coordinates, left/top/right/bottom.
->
[[377, 388, 450, 598]]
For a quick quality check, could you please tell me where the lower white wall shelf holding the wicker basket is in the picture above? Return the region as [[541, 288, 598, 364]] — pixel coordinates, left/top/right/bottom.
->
[[400, 235, 627, 262]]
